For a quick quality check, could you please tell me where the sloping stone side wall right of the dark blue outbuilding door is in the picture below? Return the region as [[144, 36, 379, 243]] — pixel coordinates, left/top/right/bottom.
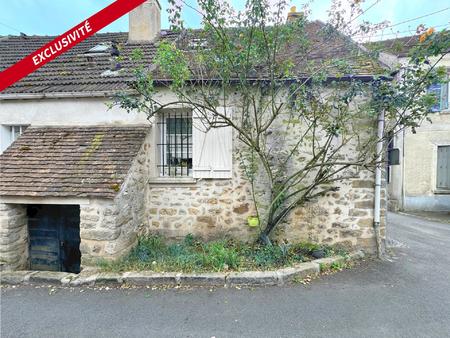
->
[[80, 133, 151, 265]]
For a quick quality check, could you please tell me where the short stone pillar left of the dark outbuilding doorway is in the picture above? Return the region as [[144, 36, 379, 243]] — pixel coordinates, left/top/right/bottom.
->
[[0, 203, 28, 271]]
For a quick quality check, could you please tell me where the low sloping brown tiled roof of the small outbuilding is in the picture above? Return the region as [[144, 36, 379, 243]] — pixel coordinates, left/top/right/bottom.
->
[[0, 127, 148, 199]]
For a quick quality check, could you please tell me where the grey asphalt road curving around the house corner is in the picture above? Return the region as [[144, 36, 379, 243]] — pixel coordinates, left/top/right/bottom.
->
[[1, 214, 450, 338]]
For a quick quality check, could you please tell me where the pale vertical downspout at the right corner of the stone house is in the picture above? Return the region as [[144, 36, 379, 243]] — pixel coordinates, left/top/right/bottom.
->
[[373, 111, 384, 258]]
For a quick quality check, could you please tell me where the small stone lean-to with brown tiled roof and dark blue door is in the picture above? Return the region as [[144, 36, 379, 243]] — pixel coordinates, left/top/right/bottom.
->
[[0, 126, 149, 273]]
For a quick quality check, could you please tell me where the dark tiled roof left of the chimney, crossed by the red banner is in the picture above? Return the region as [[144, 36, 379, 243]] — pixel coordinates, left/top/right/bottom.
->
[[0, 32, 176, 94]]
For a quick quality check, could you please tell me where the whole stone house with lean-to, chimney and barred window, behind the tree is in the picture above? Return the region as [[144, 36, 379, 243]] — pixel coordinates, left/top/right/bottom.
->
[[0, 0, 384, 272]]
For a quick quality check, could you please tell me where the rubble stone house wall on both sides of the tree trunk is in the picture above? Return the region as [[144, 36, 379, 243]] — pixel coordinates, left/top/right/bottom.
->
[[144, 167, 386, 253]]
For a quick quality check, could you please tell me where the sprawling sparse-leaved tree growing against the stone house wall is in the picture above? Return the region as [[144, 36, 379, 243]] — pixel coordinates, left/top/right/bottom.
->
[[115, 0, 449, 244]]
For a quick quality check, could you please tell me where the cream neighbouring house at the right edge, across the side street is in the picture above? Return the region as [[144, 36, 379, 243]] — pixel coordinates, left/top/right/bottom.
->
[[370, 36, 450, 211]]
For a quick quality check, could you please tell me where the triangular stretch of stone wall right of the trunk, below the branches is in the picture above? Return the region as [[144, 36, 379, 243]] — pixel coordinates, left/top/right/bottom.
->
[[279, 172, 386, 253]]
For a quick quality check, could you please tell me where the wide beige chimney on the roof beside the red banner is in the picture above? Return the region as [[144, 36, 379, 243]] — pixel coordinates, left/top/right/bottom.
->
[[128, 0, 161, 43]]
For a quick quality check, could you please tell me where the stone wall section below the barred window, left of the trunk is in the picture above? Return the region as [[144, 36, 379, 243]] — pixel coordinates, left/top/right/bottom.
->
[[145, 174, 257, 240]]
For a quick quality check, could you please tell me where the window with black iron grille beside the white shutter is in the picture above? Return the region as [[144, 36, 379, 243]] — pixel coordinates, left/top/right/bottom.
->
[[157, 111, 192, 177]]
